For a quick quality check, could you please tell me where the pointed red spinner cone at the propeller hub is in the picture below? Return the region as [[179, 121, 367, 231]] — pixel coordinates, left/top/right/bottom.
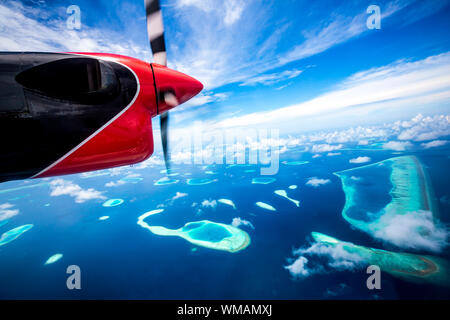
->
[[152, 64, 203, 114]]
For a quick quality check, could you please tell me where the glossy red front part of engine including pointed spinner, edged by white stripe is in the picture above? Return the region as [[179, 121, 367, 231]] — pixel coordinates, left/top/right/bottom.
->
[[33, 53, 203, 178]]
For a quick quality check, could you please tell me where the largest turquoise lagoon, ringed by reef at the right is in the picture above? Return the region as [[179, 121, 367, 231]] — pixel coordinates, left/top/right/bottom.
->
[[334, 156, 438, 244]]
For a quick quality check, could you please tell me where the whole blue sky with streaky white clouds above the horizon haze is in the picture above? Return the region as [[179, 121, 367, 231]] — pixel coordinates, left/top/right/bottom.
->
[[0, 0, 450, 133]]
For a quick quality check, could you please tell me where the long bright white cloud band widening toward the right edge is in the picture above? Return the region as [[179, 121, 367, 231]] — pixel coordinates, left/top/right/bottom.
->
[[209, 52, 450, 128]]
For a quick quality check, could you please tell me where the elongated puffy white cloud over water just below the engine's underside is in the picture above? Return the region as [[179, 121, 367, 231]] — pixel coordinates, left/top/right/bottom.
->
[[50, 179, 106, 203]]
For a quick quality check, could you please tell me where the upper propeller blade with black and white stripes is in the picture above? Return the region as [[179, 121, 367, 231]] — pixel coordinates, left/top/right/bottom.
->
[[145, 0, 167, 66]]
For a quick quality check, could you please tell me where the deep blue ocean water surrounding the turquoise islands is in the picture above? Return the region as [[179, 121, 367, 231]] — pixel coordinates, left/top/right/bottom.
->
[[0, 148, 450, 299]]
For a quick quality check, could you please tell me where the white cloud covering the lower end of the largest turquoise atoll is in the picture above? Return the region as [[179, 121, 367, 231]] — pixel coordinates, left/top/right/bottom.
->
[[370, 210, 448, 252]]
